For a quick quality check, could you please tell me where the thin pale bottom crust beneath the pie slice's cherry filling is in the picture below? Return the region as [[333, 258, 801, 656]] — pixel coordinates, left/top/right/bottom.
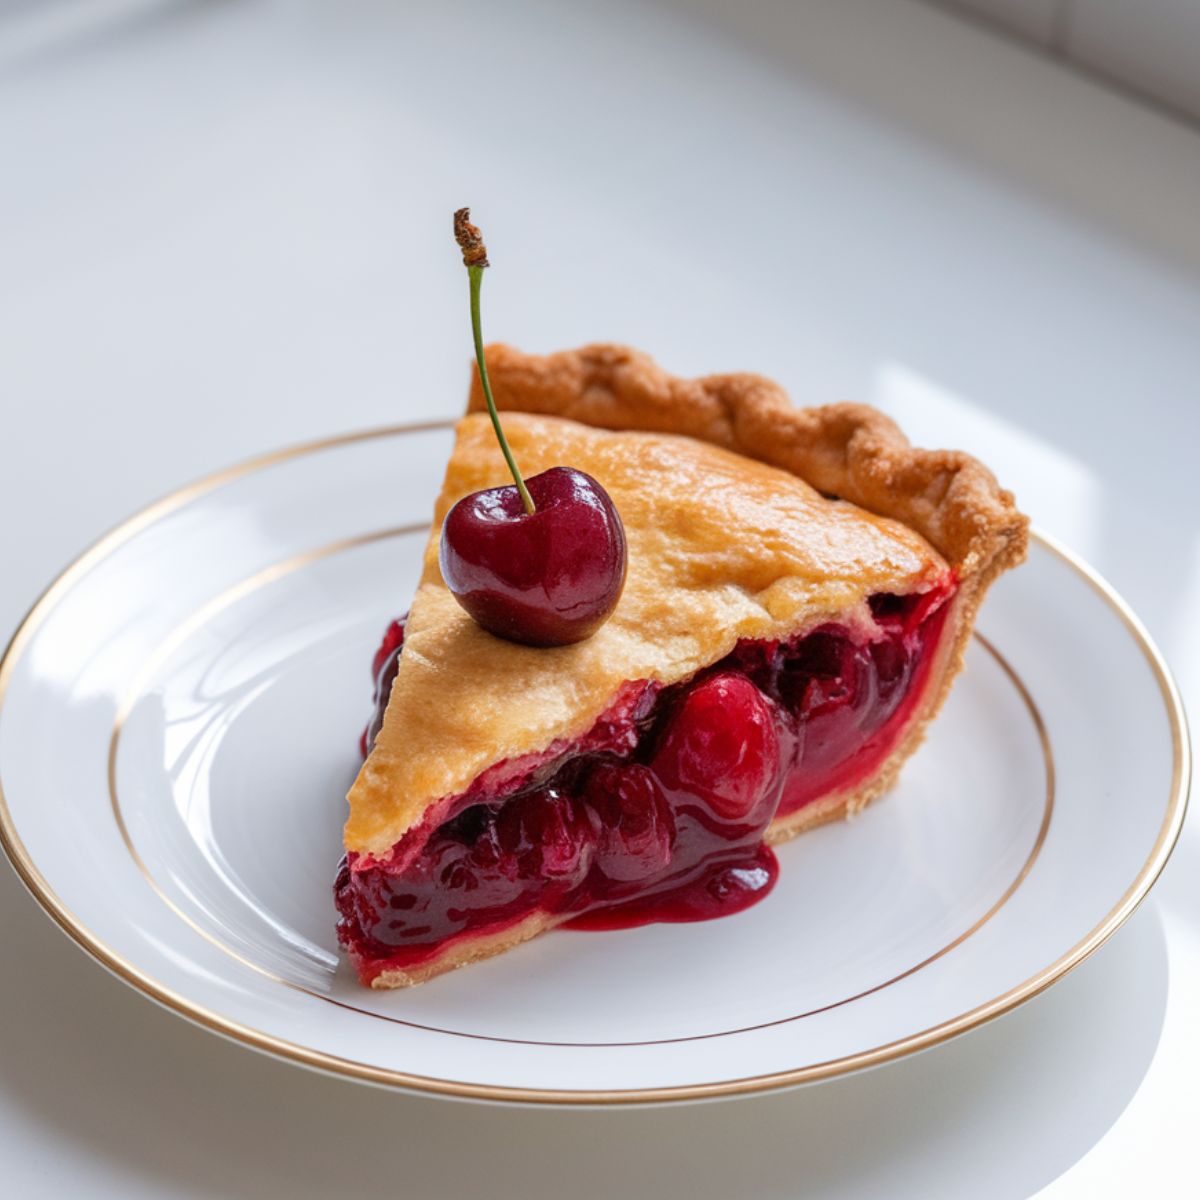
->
[[371, 583, 984, 988]]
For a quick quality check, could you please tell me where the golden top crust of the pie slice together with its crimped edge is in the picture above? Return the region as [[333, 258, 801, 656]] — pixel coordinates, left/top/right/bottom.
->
[[346, 346, 1028, 856]]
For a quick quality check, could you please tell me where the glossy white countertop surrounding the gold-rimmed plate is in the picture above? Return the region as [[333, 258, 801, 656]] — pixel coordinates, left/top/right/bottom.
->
[[0, 0, 1200, 1200]]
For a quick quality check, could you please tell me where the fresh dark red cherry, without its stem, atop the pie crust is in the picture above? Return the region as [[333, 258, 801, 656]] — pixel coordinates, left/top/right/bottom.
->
[[440, 467, 625, 646]]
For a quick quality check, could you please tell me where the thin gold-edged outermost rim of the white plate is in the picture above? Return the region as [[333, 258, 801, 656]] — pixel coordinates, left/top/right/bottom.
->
[[0, 419, 1192, 1105]]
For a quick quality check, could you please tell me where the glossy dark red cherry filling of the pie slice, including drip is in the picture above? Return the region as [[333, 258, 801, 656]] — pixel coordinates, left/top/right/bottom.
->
[[334, 578, 955, 983]]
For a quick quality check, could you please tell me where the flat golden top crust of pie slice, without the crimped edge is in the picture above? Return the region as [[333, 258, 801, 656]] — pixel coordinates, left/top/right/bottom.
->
[[346, 413, 947, 856]]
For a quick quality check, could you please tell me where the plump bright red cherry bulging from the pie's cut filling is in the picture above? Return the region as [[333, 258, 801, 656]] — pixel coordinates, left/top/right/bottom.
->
[[650, 672, 780, 822]]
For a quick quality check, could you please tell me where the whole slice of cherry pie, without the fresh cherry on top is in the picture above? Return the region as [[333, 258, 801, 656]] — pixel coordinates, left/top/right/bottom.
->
[[335, 346, 1027, 988]]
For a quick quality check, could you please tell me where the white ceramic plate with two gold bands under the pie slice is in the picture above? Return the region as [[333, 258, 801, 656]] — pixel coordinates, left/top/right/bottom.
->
[[0, 425, 1188, 1103]]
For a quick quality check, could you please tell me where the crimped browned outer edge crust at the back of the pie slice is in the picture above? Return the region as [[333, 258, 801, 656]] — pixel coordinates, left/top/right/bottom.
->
[[469, 344, 1028, 581]]
